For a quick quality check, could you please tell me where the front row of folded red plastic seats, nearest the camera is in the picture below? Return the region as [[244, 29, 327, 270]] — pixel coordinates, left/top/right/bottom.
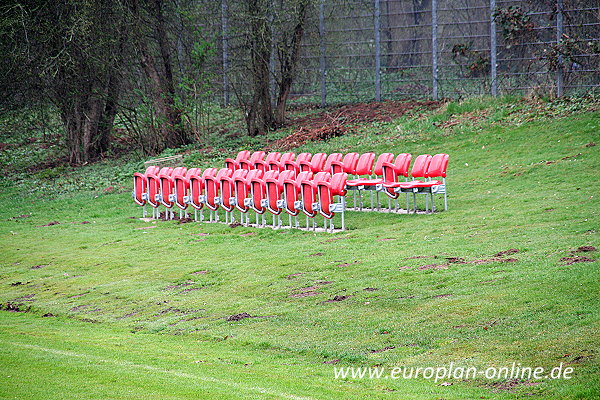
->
[[133, 166, 347, 229]]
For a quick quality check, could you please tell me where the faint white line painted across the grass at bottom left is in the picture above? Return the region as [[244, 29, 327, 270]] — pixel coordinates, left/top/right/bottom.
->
[[10, 343, 314, 400]]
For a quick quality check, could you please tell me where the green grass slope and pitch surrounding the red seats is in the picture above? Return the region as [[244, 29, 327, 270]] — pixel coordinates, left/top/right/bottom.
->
[[0, 99, 600, 399]]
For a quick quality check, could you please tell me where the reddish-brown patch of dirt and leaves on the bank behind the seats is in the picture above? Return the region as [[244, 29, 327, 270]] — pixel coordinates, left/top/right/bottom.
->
[[270, 101, 442, 150]]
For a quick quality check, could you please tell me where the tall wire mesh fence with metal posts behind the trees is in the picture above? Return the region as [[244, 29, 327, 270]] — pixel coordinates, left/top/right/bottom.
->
[[213, 0, 600, 105]]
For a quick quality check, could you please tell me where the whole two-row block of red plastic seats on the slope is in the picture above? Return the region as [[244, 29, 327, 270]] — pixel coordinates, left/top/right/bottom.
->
[[133, 151, 448, 230]]
